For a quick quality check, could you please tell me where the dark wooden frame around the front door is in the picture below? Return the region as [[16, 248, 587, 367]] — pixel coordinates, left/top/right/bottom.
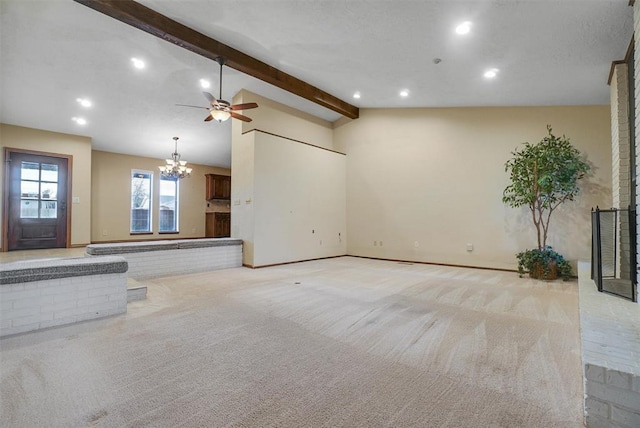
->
[[2, 147, 73, 253]]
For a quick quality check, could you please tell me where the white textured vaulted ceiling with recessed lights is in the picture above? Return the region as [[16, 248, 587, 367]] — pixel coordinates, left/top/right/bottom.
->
[[0, 0, 633, 167]]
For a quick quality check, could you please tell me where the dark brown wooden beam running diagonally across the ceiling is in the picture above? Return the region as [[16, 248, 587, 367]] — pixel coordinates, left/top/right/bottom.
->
[[74, 0, 360, 119]]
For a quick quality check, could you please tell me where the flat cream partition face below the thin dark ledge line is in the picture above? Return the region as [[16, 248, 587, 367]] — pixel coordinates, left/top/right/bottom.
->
[[253, 132, 347, 266]]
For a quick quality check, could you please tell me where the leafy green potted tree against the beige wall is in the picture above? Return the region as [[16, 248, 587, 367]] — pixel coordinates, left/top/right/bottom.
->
[[502, 125, 590, 279]]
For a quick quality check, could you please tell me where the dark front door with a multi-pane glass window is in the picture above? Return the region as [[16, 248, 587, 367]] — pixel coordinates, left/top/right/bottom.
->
[[4, 149, 69, 251]]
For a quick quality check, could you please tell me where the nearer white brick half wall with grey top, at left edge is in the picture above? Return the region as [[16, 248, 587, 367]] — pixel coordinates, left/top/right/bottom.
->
[[0, 257, 127, 336]]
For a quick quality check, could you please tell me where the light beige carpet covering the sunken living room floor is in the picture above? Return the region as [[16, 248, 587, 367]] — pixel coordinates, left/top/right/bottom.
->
[[0, 257, 582, 428]]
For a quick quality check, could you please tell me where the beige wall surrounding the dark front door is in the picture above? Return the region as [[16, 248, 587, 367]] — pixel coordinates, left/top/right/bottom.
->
[[0, 124, 91, 246]]
